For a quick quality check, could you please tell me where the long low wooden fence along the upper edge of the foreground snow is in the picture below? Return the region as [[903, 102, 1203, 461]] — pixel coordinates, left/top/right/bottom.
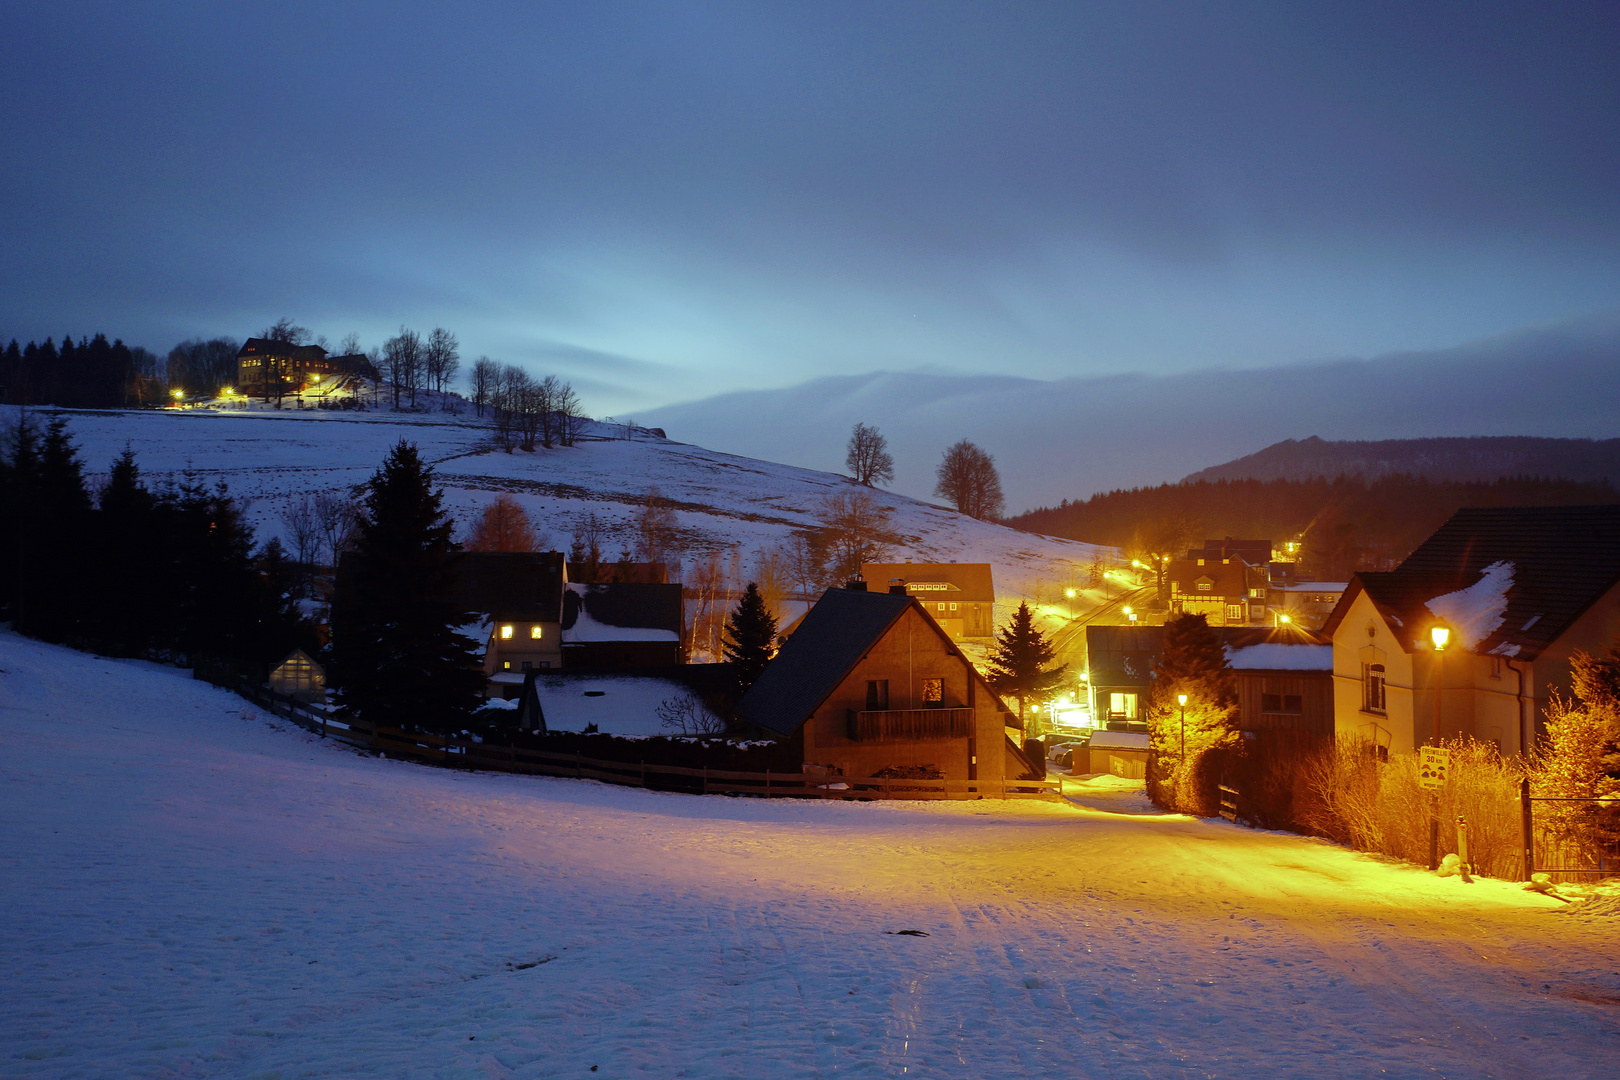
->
[[198, 670, 1059, 800]]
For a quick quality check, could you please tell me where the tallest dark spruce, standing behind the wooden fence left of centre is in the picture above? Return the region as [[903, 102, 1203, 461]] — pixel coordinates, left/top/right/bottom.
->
[[330, 440, 483, 733]]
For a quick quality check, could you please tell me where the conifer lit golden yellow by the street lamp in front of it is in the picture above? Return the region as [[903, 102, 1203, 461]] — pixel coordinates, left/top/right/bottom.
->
[[1147, 615, 1238, 814]]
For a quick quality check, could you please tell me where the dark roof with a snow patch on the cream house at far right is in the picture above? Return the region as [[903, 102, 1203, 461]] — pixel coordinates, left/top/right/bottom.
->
[[1322, 505, 1620, 657]]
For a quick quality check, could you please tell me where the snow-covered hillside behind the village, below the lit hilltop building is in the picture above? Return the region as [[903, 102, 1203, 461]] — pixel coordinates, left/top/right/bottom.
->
[[6, 401, 1108, 619]]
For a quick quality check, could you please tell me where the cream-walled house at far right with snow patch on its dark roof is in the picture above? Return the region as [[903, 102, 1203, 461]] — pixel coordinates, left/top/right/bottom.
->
[[1322, 505, 1620, 755]]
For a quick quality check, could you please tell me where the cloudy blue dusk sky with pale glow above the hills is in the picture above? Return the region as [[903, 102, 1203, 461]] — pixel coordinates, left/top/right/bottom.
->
[[0, 0, 1620, 415]]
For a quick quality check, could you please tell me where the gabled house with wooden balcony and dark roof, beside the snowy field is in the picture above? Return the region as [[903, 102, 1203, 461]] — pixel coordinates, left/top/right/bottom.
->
[[737, 581, 1045, 782]]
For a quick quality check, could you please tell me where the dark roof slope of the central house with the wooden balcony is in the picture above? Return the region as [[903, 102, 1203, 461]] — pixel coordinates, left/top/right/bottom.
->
[[737, 589, 913, 735]]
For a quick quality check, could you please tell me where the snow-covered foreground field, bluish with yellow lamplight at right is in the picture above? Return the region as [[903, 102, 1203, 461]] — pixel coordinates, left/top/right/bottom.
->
[[0, 633, 1620, 1080]]
